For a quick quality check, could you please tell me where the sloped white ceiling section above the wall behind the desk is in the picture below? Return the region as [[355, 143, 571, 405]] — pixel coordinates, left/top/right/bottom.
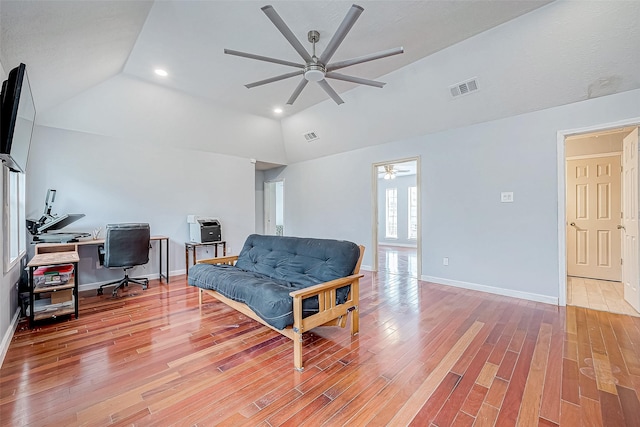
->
[[37, 74, 286, 164]]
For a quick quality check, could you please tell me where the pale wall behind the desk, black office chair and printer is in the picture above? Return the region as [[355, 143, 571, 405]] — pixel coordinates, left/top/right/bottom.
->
[[27, 126, 255, 285]]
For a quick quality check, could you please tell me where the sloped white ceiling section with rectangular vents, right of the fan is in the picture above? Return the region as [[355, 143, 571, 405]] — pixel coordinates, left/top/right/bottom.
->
[[282, 1, 640, 163]]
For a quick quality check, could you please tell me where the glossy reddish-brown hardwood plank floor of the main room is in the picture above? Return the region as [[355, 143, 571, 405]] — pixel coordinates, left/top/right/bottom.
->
[[0, 273, 640, 426]]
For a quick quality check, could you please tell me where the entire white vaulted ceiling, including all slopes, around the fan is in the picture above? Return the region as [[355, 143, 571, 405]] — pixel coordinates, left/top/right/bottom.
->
[[0, 0, 640, 164]]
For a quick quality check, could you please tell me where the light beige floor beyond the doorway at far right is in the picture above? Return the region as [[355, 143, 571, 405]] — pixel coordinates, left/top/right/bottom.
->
[[567, 276, 640, 316]]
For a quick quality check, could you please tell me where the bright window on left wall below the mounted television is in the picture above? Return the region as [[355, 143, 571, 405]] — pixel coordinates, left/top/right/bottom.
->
[[3, 167, 27, 273]]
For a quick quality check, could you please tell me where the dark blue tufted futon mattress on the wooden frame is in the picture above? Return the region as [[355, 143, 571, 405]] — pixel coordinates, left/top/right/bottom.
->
[[189, 234, 360, 329]]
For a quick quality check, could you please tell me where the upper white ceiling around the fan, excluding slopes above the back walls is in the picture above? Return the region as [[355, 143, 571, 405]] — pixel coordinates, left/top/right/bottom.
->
[[0, 0, 550, 118]]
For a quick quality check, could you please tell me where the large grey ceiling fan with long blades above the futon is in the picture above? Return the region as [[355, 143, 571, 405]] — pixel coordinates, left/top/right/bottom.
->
[[224, 4, 404, 105]]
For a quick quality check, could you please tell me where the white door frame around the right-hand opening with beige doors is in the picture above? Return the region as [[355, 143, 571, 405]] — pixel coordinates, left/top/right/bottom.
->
[[556, 117, 640, 306]]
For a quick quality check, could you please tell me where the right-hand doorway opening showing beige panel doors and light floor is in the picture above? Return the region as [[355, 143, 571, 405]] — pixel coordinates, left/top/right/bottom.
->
[[561, 126, 640, 316]]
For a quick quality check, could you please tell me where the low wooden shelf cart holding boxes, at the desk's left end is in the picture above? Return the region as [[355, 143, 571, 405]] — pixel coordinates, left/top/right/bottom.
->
[[27, 251, 80, 328]]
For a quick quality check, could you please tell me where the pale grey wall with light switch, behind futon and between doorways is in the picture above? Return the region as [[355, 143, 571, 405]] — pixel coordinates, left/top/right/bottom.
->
[[271, 90, 640, 302]]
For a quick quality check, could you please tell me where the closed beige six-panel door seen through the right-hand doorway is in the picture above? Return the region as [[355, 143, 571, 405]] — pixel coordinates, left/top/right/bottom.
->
[[567, 156, 622, 281]]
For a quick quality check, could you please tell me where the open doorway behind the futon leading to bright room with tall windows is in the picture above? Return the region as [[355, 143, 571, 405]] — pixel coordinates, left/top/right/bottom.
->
[[372, 157, 421, 278]]
